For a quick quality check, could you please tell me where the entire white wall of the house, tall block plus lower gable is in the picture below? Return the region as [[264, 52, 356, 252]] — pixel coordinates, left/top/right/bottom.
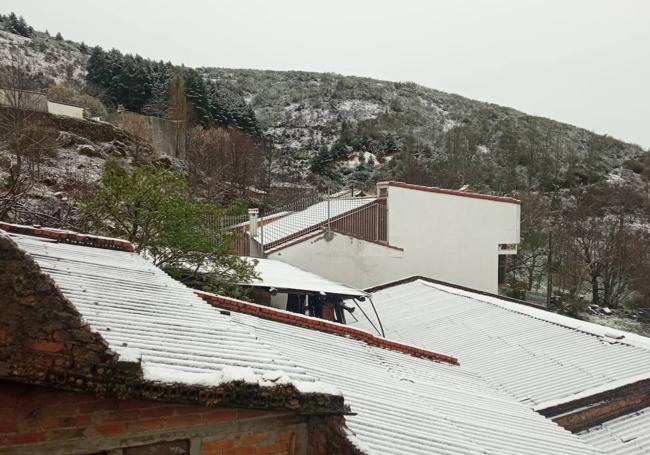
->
[[269, 185, 520, 293]]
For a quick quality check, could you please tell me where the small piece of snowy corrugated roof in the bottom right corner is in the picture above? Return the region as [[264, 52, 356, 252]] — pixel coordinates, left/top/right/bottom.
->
[[579, 408, 650, 455]]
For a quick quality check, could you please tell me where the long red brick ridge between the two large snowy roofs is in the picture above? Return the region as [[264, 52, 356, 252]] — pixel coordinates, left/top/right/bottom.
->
[[195, 291, 460, 365]]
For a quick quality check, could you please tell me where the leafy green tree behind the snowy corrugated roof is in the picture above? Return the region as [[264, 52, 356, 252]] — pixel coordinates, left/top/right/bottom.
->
[[80, 159, 254, 296]]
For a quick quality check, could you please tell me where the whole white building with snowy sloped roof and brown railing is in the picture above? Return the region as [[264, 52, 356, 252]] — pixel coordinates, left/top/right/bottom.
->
[[255, 182, 520, 292]]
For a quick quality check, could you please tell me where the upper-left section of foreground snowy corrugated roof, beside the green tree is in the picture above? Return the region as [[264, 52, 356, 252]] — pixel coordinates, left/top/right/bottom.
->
[[11, 234, 317, 394]]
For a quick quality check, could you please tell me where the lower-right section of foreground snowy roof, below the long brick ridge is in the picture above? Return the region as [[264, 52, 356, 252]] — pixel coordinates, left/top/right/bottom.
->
[[232, 306, 599, 455]]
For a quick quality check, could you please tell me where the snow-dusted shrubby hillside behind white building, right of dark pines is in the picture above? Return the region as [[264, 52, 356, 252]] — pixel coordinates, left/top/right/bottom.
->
[[201, 68, 643, 189]]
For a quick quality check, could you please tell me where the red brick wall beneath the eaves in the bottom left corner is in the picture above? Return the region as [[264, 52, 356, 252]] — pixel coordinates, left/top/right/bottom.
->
[[0, 381, 308, 455]]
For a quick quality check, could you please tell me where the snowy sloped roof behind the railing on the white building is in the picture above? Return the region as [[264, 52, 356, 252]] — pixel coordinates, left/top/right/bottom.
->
[[255, 197, 376, 245]]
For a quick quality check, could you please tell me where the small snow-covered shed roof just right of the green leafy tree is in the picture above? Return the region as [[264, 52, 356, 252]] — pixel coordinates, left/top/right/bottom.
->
[[243, 258, 369, 297]]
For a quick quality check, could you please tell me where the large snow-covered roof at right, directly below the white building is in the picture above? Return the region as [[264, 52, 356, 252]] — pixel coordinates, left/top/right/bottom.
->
[[355, 279, 650, 410]]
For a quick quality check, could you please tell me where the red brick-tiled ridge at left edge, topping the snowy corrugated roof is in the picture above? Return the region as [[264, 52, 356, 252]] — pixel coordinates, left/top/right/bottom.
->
[[0, 221, 135, 253]]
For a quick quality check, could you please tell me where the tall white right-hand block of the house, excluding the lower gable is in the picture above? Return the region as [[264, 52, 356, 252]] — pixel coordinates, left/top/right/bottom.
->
[[388, 186, 520, 292]]
